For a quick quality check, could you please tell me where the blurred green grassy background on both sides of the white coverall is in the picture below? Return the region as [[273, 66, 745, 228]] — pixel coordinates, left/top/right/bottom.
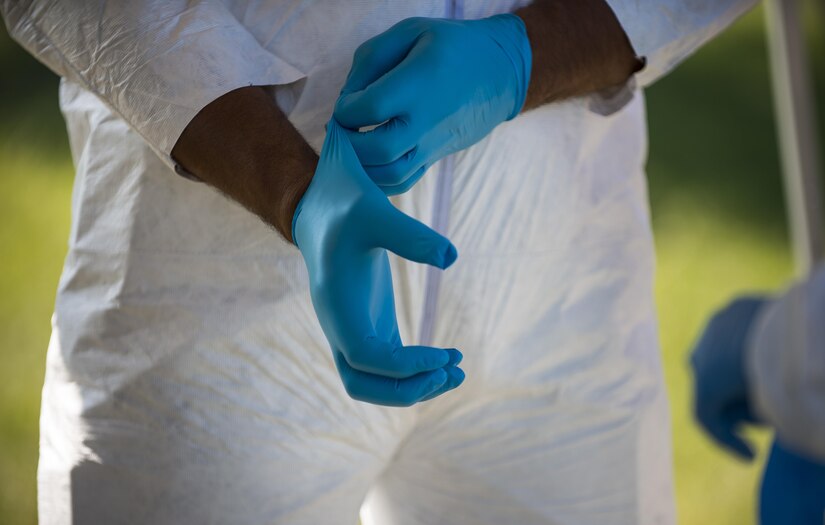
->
[[0, 5, 825, 525]]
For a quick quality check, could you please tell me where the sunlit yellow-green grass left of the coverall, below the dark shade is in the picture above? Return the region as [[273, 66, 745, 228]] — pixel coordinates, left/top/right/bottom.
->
[[0, 148, 71, 524]]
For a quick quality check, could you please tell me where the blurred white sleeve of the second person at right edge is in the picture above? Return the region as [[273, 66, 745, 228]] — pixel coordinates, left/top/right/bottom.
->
[[745, 266, 825, 460]]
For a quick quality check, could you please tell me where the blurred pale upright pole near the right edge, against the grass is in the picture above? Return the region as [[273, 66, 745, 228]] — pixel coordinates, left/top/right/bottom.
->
[[765, 0, 825, 277]]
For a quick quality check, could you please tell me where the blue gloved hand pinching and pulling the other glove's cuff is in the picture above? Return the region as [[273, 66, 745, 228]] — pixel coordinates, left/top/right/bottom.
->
[[335, 14, 532, 195]]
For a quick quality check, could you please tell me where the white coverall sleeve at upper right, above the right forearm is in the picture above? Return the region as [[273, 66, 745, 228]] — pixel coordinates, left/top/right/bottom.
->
[[607, 0, 756, 87]]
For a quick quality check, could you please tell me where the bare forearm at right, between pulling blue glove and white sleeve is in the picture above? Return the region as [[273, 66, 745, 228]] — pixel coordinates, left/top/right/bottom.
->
[[515, 0, 642, 111]]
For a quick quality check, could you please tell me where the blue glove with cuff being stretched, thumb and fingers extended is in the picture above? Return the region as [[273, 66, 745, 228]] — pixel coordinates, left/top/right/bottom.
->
[[292, 119, 464, 406]]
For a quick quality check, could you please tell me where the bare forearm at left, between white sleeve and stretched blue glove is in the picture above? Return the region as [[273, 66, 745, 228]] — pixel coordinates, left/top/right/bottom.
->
[[172, 87, 318, 242]]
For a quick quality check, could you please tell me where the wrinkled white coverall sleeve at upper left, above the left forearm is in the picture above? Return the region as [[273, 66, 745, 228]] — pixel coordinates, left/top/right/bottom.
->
[[0, 0, 304, 167]]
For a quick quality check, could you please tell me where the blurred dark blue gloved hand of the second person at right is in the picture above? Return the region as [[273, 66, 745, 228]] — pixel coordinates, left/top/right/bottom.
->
[[691, 297, 767, 459]]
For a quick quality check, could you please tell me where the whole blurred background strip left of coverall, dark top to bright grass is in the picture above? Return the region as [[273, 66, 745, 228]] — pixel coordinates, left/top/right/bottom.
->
[[0, 24, 73, 524]]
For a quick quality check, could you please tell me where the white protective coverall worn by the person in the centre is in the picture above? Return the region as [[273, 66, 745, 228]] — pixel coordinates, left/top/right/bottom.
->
[[2, 0, 754, 525]]
